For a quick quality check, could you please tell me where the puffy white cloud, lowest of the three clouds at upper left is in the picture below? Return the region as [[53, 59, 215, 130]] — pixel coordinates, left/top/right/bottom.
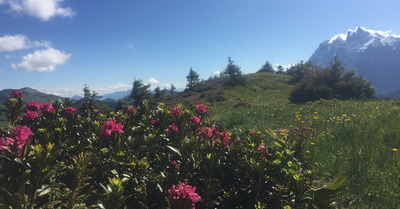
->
[[11, 47, 71, 72]]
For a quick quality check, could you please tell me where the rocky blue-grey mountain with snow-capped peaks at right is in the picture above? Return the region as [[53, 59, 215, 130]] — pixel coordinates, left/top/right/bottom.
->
[[310, 27, 400, 95]]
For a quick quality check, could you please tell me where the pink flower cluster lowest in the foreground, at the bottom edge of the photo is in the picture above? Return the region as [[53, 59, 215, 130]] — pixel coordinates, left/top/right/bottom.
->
[[168, 183, 201, 209]]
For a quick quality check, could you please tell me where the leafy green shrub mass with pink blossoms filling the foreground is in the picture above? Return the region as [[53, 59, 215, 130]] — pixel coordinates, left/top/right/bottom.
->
[[0, 90, 343, 209]]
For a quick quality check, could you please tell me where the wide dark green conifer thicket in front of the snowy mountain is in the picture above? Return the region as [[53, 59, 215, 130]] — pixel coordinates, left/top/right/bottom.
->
[[290, 57, 375, 103]]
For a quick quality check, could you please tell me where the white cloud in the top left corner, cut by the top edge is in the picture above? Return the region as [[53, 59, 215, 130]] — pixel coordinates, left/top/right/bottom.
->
[[0, 0, 75, 21]]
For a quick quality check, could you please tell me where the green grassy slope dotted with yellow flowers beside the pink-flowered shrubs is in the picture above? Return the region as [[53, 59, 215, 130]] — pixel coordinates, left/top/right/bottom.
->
[[167, 73, 400, 208]]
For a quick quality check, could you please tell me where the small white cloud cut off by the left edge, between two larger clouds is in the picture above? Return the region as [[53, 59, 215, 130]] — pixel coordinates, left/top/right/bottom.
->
[[0, 34, 31, 52]]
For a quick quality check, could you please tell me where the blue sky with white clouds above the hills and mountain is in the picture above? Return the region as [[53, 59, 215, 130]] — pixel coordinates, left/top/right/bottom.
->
[[0, 0, 400, 97]]
